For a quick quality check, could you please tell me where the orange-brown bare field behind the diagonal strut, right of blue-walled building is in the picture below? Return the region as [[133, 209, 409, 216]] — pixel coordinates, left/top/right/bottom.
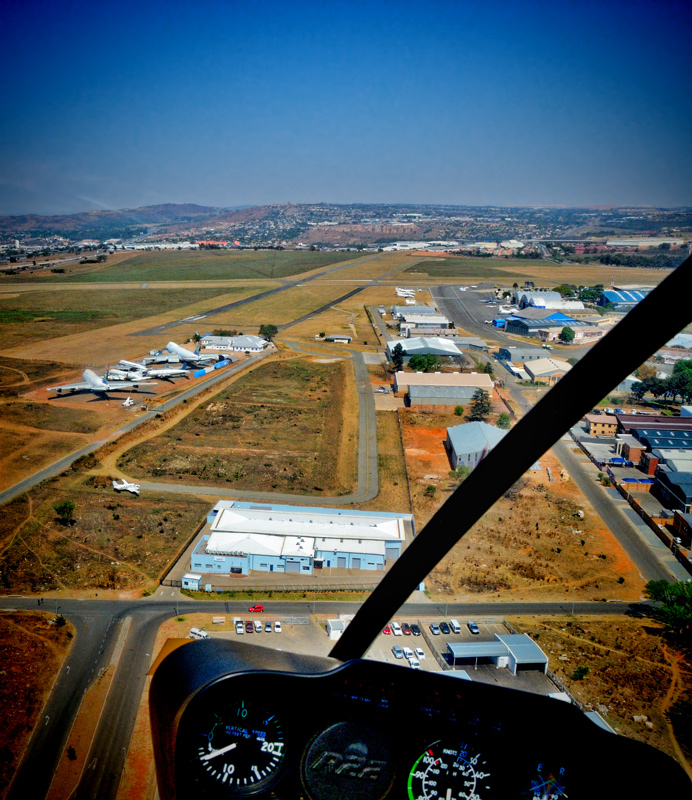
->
[[400, 409, 644, 602]]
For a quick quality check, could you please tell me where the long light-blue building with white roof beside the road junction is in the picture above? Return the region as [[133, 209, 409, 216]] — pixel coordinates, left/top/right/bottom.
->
[[190, 500, 414, 575]]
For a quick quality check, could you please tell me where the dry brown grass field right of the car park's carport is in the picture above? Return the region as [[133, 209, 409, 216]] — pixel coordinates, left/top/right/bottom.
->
[[509, 616, 692, 777]]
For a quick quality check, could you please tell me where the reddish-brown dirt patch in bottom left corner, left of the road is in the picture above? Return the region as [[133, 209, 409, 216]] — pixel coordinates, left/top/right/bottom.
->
[[0, 611, 74, 796]]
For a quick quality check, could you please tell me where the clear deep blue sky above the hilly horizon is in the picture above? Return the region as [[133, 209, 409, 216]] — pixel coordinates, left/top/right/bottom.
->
[[0, 0, 692, 214]]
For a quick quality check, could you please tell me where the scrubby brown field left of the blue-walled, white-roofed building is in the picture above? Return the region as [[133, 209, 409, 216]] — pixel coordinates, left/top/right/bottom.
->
[[0, 457, 209, 597]]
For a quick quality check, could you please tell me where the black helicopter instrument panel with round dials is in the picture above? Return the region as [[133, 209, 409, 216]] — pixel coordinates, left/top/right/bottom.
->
[[150, 640, 690, 800]]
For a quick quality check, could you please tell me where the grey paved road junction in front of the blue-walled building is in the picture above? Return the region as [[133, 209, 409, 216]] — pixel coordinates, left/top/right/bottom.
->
[[0, 598, 647, 800]]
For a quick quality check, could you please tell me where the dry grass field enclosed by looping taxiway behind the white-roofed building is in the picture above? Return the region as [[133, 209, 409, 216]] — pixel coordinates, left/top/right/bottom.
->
[[118, 358, 357, 495]]
